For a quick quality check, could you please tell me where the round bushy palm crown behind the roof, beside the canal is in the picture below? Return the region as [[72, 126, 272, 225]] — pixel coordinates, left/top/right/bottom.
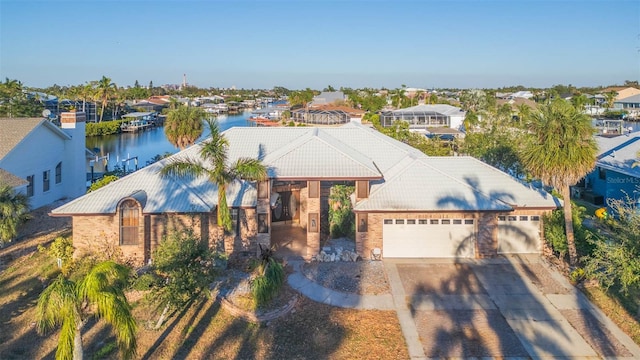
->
[[164, 106, 205, 150]]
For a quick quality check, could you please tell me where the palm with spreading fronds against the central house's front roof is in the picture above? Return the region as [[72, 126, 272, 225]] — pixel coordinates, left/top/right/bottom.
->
[[160, 119, 267, 231]]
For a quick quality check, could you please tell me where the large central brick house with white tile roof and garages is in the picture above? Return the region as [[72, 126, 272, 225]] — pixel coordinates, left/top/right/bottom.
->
[[50, 122, 559, 263]]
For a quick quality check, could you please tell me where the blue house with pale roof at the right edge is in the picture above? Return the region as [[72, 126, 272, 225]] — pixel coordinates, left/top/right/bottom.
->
[[583, 132, 640, 205]]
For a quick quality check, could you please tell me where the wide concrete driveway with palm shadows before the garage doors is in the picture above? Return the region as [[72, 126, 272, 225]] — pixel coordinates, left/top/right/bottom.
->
[[384, 256, 640, 358]]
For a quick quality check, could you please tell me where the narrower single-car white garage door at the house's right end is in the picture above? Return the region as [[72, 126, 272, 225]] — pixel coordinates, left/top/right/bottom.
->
[[498, 215, 542, 254]]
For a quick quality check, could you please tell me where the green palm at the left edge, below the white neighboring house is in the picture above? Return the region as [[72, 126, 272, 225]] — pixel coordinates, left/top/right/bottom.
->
[[0, 183, 29, 246]]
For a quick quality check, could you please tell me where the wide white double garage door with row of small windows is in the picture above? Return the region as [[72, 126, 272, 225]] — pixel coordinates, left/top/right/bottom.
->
[[382, 219, 475, 258]]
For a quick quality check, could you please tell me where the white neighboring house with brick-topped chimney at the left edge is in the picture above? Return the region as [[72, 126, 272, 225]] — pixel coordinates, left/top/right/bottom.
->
[[0, 113, 87, 209]]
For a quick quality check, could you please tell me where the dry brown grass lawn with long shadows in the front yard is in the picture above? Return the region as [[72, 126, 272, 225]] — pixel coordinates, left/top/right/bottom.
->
[[0, 208, 408, 359]]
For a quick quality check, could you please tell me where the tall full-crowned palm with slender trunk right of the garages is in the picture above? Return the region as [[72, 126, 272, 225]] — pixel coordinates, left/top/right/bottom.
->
[[521, 99, 598, 265]]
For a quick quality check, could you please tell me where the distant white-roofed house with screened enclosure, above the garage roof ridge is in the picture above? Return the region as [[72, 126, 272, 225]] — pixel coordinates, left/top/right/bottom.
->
[[380, 104, 466, 131]]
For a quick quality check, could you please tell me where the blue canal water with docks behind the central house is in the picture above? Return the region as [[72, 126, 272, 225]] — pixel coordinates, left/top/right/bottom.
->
[[86, 112, 251, 173]]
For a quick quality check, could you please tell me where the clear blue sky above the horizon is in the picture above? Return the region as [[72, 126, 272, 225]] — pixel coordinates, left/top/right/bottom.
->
[[0, 0, 640, 89]]
